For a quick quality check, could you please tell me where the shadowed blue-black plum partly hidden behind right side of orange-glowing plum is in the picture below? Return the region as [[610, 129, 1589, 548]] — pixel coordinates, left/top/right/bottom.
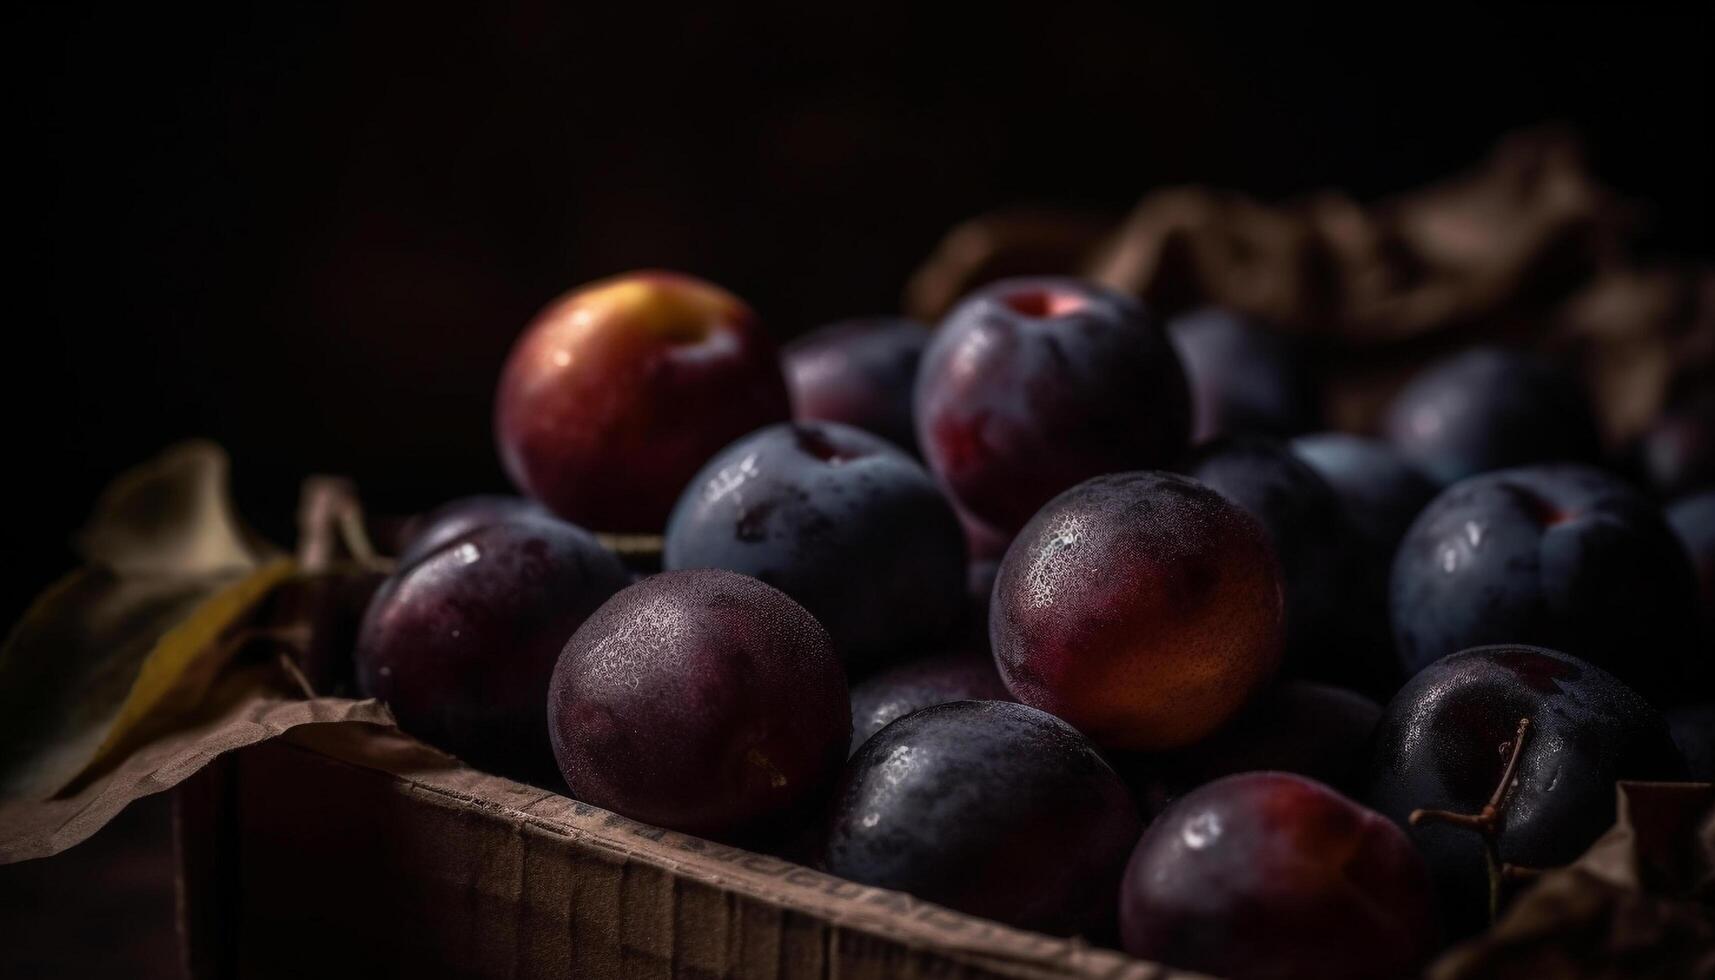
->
[[1185, 436, 1398, 695]]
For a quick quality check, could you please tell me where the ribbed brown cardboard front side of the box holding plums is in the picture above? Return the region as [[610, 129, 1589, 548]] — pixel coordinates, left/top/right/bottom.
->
[[210, 726, 1187, 978]]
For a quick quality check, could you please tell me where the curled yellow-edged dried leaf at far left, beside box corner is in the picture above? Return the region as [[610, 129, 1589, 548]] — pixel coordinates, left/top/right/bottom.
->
[[0, 443, 293, 798]]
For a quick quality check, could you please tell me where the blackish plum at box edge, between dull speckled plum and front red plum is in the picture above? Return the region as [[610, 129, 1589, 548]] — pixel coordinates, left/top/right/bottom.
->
[[823, 700, 1142, 935]]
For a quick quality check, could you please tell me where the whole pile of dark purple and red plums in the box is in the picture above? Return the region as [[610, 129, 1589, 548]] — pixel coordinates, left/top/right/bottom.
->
[[355, 273, 1715, 978]]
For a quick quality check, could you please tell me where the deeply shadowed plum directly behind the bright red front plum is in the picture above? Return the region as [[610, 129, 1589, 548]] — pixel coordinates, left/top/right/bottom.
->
[[1161, 681, 1382, 789]]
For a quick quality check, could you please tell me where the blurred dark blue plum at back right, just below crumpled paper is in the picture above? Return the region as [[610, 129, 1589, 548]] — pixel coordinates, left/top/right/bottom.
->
[[1382, 347, 1600, 486]]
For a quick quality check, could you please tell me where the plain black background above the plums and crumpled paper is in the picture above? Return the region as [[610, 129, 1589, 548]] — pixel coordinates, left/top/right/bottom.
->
[[0, 3, 1715, 621]]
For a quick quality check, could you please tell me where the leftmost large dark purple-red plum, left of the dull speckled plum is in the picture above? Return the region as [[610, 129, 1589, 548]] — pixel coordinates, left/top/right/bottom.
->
[[355, 520, 628, 779]]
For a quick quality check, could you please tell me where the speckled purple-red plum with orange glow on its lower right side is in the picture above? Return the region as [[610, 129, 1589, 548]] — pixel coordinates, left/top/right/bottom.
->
[[990, 472, 1283, 750]]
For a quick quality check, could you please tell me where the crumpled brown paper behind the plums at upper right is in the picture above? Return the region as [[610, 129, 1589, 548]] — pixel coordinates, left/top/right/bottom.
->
[[906, 130, 1715, 439]]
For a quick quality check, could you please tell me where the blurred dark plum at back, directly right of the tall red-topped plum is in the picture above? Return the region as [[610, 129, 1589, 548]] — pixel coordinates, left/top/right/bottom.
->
[[1168, 307, 1322, 443]]
